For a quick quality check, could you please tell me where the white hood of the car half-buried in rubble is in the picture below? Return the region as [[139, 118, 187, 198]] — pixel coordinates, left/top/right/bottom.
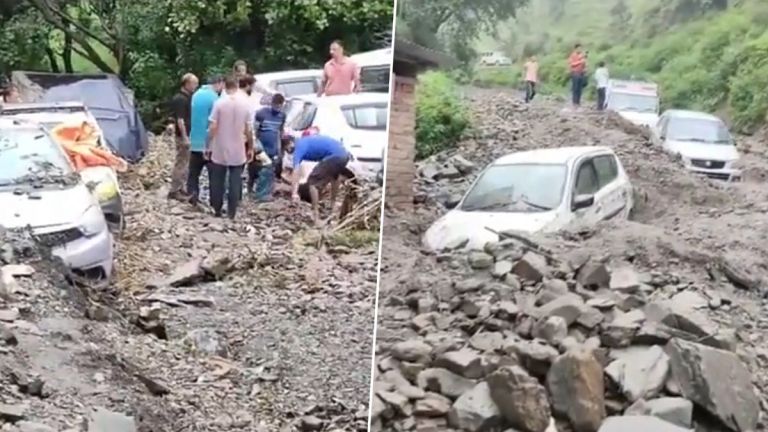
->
[[423, 210, 557, 251]]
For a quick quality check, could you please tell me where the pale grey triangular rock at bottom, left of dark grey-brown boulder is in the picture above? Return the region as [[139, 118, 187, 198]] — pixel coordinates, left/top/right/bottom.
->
[[448, 382, 501, 432]]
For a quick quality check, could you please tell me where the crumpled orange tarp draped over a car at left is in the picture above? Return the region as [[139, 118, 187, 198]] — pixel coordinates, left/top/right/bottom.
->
[[51, 122, 128, 172]]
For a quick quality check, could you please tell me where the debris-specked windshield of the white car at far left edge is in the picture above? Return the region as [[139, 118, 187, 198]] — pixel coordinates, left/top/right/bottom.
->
[[0, 128, 73, 186]]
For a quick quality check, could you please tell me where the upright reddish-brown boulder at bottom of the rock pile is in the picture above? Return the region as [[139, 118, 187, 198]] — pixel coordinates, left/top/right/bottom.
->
[[547, 348, 605, 432]]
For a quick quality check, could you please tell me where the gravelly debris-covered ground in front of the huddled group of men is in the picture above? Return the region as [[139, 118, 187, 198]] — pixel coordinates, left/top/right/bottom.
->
[[0, 138, 378, 432]]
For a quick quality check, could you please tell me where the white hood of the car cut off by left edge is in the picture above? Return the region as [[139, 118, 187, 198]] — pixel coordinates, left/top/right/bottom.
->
[[0, 184, 97, 229]]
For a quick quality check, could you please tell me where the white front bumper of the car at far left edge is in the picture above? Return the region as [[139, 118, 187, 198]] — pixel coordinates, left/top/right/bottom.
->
[[52, 230, 114, 278]]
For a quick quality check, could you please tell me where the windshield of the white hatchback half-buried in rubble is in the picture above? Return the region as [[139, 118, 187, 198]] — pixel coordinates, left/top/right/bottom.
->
[[461, 164, 568, 212]]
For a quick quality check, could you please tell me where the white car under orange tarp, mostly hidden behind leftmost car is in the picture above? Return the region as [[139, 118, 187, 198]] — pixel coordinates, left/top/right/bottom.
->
[[0, 102, 125, 233]]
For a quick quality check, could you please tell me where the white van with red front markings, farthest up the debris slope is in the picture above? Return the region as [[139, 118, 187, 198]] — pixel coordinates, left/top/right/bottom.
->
[[605, 80, 659, 127]]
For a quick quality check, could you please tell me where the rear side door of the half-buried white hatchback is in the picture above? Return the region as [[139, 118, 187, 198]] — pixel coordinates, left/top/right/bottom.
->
[[592, 153, 629, 220]]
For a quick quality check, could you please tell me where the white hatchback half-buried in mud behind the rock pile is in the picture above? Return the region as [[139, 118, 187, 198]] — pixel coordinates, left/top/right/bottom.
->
[[423, 147, 634, 251]]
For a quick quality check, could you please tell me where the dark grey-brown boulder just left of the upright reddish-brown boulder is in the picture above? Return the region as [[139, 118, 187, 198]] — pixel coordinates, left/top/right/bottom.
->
[[488, 366, 551, 432]]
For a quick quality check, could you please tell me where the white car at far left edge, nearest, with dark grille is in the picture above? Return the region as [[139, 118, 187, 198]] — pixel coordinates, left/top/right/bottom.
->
[[0, 117, 114, 277]]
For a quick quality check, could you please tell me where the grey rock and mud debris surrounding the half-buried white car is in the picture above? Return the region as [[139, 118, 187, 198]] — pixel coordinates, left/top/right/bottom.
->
[[373, 90, 768, 432]]
